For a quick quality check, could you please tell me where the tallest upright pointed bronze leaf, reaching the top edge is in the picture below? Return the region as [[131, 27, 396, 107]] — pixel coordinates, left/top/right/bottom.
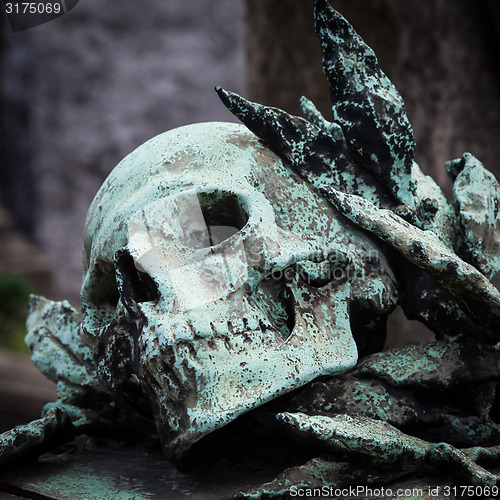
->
[[315, 0, 415, 206]]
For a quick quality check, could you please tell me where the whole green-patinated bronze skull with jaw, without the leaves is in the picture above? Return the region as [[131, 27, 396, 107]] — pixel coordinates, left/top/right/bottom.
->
[[81, 123, 395, 458]]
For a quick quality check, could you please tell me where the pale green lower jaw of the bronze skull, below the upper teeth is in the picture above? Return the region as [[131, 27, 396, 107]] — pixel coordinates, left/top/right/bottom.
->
[[137, 283, 357, 463]]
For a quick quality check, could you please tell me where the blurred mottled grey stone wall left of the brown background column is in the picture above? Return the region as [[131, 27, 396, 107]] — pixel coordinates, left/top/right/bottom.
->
[[0, 0, 244, 305]]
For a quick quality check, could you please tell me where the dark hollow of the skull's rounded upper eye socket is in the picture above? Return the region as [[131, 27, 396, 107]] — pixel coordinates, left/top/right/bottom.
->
[[198, 191, 248, 246]]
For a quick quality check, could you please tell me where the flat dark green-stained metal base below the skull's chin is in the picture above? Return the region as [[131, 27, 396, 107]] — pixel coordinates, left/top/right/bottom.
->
[[0, 444, 282, 500]]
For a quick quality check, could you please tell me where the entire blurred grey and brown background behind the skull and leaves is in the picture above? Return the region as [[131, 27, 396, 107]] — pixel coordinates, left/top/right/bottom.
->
[[0, 0, 500, 430]]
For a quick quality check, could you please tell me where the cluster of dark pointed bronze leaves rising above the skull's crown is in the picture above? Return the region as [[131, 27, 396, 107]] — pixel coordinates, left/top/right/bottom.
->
[[217, 0, 415, 208]]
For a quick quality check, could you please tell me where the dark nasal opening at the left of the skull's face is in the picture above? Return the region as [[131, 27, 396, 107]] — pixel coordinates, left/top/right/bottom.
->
[[116, 251, 160, 306]]
